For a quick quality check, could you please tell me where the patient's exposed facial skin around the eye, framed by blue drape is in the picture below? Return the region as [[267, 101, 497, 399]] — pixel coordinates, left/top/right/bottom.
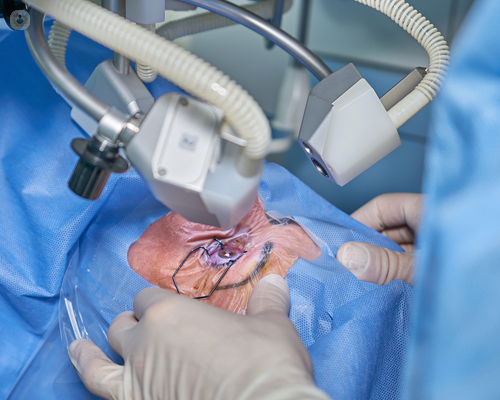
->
[[128, 200, 321, 313]]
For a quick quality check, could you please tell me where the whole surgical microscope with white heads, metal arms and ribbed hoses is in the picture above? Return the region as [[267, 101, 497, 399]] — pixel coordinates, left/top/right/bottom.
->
[[0, 0, 449, 229]]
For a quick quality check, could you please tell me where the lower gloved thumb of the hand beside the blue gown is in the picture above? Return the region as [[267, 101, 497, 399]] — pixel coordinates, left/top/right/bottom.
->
[[337, 242, 413, 285]]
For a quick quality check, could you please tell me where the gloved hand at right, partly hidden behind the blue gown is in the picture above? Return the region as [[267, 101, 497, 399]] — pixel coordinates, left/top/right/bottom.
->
[[337, 193, 422, 285]]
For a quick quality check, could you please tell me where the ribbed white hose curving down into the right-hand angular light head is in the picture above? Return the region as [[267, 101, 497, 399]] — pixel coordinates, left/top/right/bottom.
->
[[356, 0, 450, 128]]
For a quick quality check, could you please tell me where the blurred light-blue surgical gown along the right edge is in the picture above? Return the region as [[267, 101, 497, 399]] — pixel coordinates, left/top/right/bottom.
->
[[405, 0, 500, 400]]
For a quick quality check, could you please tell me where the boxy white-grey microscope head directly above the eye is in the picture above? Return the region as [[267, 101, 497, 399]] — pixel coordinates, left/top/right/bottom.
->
[[125, 93, 263, 229]]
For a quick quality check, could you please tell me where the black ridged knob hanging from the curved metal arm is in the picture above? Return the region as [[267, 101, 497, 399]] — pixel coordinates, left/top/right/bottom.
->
[[68, 136, 128, 200]]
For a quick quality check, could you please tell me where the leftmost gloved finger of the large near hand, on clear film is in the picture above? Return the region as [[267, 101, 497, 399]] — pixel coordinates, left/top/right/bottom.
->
[[68, 339, 123, 400]]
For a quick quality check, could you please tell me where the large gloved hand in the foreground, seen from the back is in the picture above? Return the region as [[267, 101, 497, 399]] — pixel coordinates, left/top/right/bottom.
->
[[69, 275, 328, 400]]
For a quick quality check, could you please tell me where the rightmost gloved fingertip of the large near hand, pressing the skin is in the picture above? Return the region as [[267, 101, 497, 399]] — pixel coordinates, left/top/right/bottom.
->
[[247, 274, 290, 316]]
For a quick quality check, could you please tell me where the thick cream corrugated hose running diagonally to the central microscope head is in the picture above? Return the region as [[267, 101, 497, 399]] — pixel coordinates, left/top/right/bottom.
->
[[28, 0, 271, 160]]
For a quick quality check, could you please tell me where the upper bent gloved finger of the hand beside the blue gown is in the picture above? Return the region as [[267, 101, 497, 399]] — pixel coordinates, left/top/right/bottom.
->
[[351, 193, 422, 232]]
